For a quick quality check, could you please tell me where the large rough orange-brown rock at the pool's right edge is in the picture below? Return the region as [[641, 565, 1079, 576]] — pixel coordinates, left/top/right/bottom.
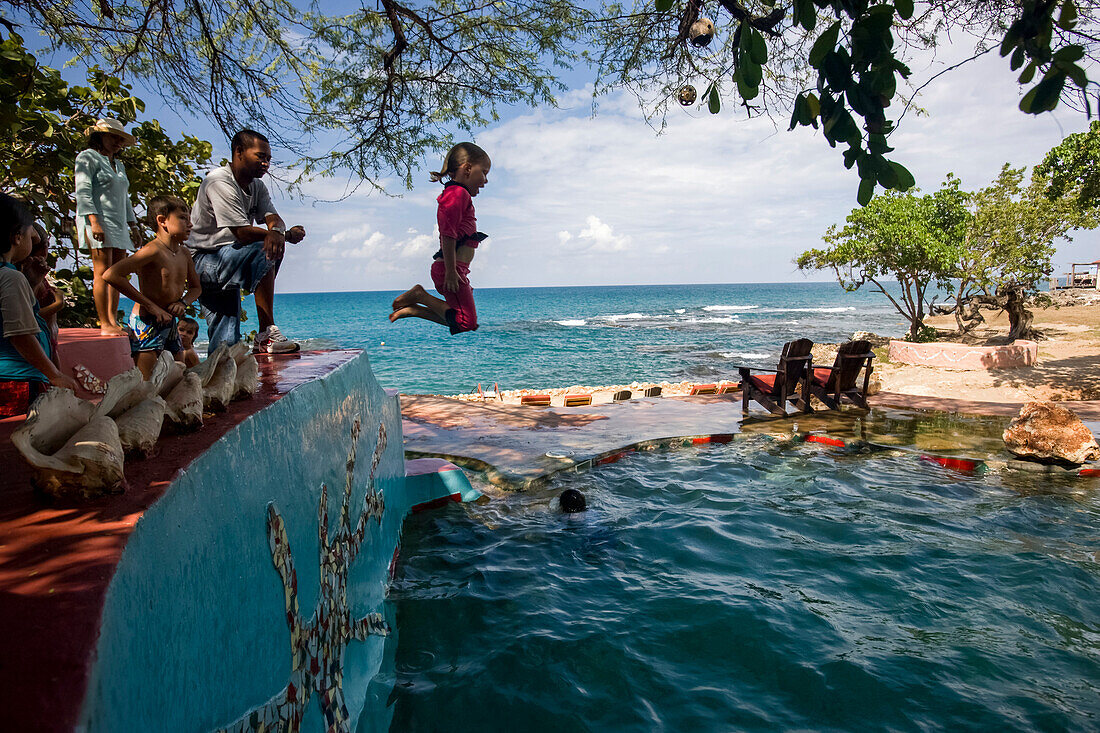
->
[[1001, 402, 1100, 464]]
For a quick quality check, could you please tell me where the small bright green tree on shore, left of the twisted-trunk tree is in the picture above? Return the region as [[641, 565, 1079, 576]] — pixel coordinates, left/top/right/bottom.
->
[[795, 185, 970, 341]]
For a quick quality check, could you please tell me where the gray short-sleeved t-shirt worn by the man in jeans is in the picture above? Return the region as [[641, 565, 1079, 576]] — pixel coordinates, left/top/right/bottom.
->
[[187, 165, 278, 252]]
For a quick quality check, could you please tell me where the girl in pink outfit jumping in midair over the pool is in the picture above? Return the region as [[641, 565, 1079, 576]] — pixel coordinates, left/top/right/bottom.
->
[[389, 143, 492, 335]]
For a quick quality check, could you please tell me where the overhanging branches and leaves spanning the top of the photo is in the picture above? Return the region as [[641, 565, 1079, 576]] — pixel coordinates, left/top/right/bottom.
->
[[0, 0, 1100, 198]]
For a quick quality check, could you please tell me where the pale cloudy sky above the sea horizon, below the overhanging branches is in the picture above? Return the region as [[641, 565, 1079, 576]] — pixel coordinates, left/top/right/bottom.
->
[[17, 15, 1100, 293]]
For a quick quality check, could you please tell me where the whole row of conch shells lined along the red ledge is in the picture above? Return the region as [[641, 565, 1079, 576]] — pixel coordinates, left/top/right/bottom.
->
[[11, 343, 260, 499]]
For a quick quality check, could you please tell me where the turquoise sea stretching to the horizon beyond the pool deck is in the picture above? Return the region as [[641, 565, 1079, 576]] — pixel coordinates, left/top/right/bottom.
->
[[242, 283, 906, 394]]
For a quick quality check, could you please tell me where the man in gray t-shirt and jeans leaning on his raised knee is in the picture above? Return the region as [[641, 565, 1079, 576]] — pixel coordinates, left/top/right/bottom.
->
[[187, 130, 306, 353]]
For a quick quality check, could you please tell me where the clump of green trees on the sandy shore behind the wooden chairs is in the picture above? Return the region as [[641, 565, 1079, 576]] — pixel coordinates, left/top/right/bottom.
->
[[796, 157, 1100, 340]]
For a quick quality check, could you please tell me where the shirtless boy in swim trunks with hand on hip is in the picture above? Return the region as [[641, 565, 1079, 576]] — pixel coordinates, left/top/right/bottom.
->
[[103, 196, 202, 380]]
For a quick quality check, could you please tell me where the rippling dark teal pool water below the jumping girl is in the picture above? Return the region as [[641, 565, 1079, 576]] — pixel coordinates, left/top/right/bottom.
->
[[389, 436, 1100, 733]]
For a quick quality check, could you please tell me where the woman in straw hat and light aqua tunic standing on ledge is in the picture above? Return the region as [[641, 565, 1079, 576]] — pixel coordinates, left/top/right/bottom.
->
[[76, 118, 138, 336]]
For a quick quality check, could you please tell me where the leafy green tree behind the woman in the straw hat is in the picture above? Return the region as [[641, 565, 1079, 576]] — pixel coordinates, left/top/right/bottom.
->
[[0, 33, 212, 326]]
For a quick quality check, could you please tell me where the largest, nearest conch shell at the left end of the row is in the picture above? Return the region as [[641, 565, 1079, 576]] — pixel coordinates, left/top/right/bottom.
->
[[11, 389, 125, 499]]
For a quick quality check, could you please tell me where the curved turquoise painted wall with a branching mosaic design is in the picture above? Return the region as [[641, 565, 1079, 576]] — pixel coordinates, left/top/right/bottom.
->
[[81, 354, 455, 732]]
